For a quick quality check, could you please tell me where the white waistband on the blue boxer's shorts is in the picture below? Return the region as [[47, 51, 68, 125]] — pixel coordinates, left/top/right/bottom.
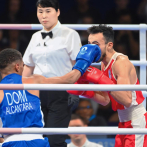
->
[[4, 134, 44, 142]]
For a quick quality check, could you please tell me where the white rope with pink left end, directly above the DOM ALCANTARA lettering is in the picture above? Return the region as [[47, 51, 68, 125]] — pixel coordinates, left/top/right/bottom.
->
[[0, 84, 147, 91]]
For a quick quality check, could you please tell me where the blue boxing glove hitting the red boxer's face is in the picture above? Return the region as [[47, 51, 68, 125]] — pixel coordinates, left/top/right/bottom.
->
[[73, 44, 101, 75]]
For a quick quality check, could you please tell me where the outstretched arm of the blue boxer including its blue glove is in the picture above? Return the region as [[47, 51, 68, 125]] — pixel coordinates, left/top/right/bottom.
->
[[24, 44, 101, 84]]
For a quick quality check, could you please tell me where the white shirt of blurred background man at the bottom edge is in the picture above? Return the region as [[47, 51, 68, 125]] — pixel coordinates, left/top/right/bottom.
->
[[67, 139, 103, 147]]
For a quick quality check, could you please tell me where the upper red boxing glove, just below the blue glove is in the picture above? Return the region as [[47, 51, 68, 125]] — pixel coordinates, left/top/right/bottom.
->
[[81, 66, 114, 84]]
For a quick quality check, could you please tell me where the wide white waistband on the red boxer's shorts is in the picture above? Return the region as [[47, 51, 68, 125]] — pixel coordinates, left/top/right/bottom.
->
[[117, 104, 146, 122]]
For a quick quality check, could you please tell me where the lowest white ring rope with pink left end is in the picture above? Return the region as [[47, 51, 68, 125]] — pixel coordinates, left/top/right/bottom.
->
[[0, 127, 147, 135]]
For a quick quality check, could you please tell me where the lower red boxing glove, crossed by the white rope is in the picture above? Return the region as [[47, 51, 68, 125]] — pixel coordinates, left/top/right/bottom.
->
[[67, 78, 94, 98]]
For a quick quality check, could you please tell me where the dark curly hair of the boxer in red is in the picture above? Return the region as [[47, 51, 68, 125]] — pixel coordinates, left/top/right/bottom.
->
[[88, 24, 114, 43]]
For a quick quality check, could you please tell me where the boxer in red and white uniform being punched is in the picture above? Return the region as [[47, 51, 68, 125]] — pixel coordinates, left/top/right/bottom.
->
[[69, 25, 147, 147]]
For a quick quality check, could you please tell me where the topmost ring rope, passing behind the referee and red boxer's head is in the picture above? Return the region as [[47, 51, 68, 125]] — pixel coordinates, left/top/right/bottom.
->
[[0, 24, 147, 30]]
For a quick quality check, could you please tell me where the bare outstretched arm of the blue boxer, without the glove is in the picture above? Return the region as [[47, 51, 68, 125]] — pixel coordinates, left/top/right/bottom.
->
[[23, 69, 81, 84]]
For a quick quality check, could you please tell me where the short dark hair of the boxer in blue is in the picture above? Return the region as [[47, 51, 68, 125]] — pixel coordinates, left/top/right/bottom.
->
[[0, 48, 22, 70]]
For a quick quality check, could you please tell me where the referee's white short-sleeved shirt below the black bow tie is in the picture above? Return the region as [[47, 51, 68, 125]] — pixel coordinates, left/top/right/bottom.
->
[[23, 21, 81, 77]]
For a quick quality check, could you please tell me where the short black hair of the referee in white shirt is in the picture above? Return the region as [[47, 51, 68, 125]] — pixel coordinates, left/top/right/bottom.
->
[[36, 0, 59, 11]]
